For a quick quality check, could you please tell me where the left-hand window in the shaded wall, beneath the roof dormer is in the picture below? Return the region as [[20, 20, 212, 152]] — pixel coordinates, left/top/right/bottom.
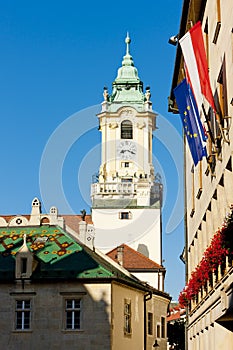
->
[[15, 300, 31, 330]]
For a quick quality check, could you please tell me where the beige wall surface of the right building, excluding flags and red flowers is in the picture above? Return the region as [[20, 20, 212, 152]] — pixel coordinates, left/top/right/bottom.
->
[[180, 0, 233, 350]]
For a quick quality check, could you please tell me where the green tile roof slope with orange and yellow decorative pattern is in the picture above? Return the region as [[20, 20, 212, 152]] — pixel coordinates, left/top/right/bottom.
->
[[0, 226, 114, 280]]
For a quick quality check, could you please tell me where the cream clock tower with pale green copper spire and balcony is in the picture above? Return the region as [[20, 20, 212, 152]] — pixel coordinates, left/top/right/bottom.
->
[[91, 34, 162, 264]]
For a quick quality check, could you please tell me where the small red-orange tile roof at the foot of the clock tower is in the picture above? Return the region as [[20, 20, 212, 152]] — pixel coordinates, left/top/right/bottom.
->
[[106, 244, 164, 272]]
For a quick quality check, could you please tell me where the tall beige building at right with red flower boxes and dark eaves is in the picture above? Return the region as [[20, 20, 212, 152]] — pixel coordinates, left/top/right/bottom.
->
[[169, 0, 233, 350]]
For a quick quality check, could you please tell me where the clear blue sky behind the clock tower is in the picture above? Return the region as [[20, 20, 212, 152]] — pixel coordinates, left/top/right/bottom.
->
[[0, 0, 184, 299]]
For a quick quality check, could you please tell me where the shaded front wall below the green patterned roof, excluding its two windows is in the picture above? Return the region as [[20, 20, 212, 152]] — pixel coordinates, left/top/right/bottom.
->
[[0, 282, 111, 350]]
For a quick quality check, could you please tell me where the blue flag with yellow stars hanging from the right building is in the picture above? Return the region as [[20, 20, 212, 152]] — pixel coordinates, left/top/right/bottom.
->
[[173, 79, 207, 165]]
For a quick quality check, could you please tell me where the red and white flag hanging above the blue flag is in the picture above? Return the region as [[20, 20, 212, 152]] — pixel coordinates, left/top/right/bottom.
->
[[179, 21, 216, 112]]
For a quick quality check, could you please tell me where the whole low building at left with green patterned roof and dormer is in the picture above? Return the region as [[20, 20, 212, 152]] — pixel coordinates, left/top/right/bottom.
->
[[0, 198, 170, 350]]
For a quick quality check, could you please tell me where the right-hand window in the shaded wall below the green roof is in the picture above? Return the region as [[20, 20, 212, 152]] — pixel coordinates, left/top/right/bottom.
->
[[65, 299, 81, 330]]
